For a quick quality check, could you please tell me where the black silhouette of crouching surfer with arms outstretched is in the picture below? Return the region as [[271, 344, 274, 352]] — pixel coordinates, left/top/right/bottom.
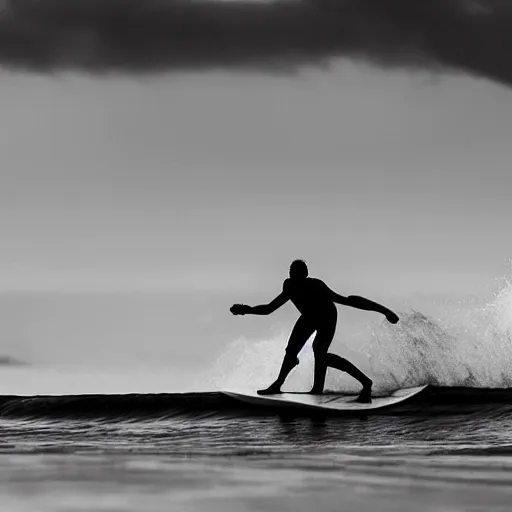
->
[[230, 260, 399, 403]]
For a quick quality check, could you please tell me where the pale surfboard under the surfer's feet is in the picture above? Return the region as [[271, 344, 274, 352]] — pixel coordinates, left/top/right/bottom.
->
[[223, 386, 427, 412]]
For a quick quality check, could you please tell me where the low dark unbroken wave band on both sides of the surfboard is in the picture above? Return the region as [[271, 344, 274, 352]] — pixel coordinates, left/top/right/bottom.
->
[[0, 387, 512, 421]]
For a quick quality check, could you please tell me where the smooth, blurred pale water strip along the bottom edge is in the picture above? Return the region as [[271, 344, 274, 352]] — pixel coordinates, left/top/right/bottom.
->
[[0, 454, 512, 512]]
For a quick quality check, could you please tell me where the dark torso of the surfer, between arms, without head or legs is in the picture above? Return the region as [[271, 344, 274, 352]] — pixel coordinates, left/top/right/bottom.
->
[[283, 277, 337, 318]]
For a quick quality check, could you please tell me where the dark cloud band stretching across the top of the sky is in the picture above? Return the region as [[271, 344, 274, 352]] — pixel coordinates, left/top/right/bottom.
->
[[0, 0, 512, 84]]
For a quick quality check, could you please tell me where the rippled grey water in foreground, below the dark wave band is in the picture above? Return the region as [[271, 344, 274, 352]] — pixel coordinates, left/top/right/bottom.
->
[[0, 415, 512, 512]]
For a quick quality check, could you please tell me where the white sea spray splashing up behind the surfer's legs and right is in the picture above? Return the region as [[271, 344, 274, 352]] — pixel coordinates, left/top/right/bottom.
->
[[212, 270, 512, 394]]
